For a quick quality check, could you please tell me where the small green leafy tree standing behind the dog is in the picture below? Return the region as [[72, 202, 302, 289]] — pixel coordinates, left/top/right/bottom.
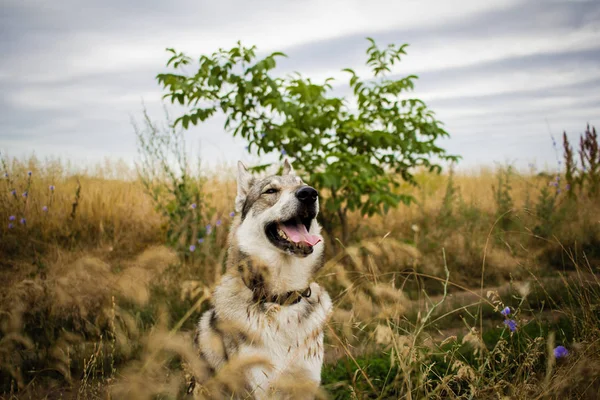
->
[[157, 39, 458, 242]]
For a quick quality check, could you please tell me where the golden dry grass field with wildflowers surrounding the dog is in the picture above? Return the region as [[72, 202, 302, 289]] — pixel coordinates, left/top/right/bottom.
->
[[0, 134, 600, 399]]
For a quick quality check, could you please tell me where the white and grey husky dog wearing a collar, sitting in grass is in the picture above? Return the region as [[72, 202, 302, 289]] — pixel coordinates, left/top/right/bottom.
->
[[195, 160, 332, 399]]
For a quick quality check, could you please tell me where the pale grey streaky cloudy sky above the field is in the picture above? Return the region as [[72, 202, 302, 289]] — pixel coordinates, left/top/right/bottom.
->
[[0, 0, 600, 168]]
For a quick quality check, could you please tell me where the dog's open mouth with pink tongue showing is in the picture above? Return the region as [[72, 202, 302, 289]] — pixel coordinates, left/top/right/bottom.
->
[[266, 218, 321, 256]]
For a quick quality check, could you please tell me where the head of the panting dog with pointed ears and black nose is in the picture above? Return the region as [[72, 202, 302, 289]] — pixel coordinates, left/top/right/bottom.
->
[[235, 160, 323, 262]]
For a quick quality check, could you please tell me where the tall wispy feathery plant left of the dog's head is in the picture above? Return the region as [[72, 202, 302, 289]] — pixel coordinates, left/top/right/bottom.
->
[[134, 111, 214, 251]]
